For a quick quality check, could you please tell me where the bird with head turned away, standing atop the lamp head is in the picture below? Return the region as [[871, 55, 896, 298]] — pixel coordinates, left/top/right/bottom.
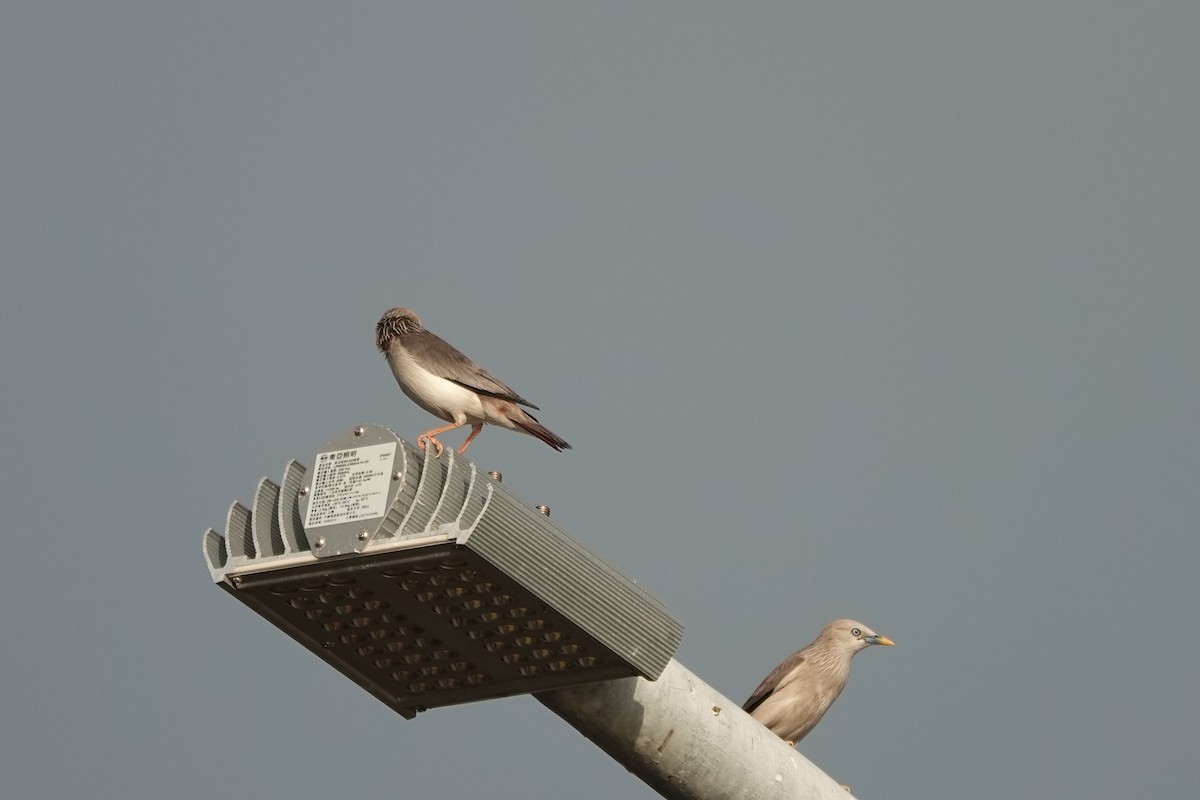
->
[[376, 307, 571, 458]]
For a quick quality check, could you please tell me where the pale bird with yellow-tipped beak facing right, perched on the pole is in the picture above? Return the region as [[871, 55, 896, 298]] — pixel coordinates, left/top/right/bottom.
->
[[742, 619, 894, 745]]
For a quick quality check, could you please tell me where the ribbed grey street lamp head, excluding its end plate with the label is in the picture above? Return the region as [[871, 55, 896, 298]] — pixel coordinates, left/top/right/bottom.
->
[[204, 426, 683, 717]]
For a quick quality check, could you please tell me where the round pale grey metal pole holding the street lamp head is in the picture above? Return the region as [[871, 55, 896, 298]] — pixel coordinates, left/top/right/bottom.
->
[[534, 658, 851, 800]]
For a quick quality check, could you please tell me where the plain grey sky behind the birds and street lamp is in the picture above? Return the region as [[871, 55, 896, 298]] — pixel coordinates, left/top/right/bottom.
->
[[0, 0, 1200, 800]]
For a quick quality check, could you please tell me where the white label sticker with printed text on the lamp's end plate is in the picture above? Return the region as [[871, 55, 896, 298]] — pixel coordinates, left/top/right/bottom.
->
[[304, 443, 396, 530]]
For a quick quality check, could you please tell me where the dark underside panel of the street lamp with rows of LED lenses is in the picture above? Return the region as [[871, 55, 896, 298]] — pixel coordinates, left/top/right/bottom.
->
[[248, 554, 629, 709]]
